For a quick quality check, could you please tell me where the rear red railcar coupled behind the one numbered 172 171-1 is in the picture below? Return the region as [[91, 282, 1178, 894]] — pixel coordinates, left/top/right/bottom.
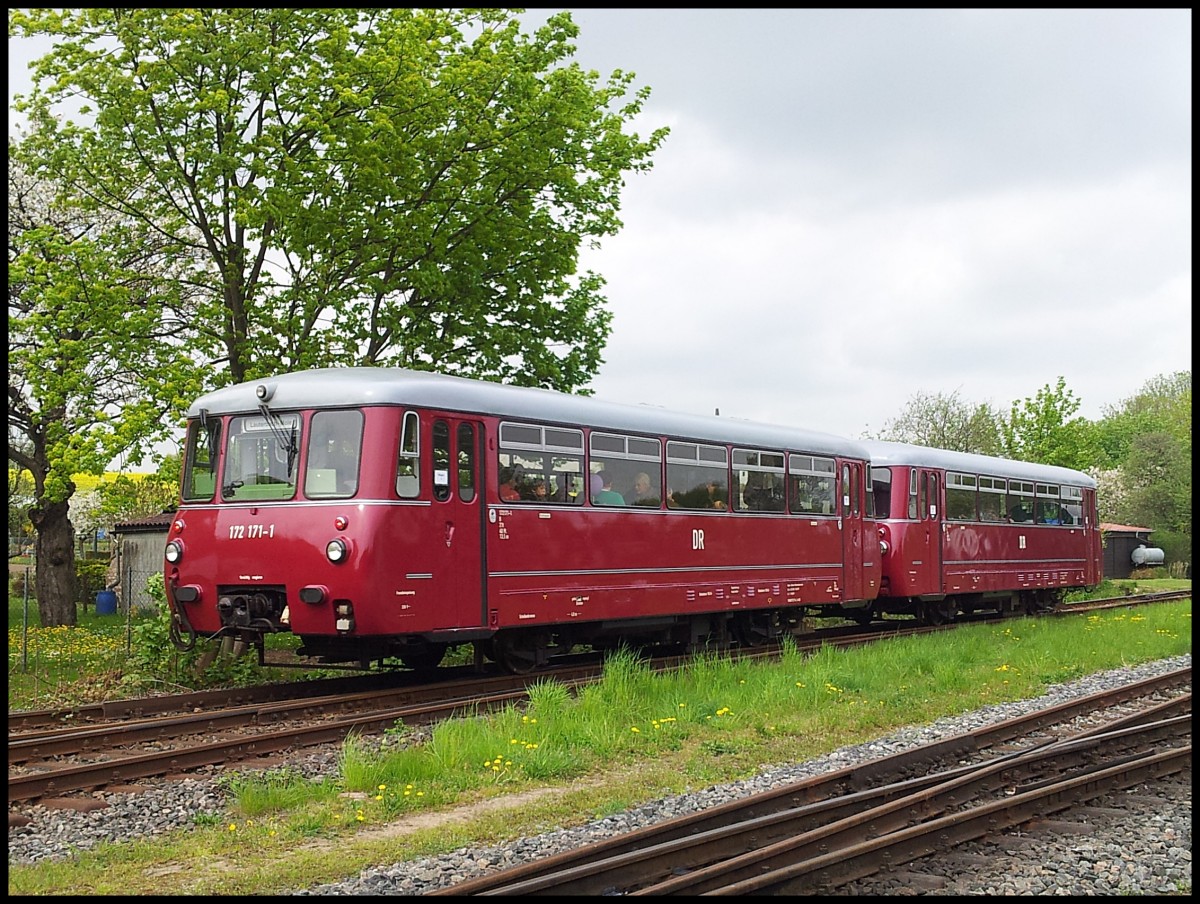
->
[[864, 442, 1103, 623]]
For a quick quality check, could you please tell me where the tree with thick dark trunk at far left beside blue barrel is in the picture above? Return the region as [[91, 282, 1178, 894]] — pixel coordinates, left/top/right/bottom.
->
[[8, 158, 199, 627]]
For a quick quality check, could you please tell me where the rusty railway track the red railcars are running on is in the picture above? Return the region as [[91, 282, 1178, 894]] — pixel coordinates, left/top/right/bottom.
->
[[8, 592, 1190, 803]]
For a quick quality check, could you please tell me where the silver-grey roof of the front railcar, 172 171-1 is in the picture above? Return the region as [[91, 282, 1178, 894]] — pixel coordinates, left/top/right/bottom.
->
[[187, 367, 868, 460]]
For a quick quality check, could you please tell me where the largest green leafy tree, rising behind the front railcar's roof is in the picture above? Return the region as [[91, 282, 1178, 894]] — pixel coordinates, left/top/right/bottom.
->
[[8, 7, 666, 391]]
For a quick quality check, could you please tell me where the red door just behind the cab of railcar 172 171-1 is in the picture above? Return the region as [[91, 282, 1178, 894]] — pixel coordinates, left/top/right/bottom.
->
[[428, 414, 485, 628]]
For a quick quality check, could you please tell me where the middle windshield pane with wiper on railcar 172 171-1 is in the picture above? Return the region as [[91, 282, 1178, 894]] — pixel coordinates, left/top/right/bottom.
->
[[221, 413, 300, 502]]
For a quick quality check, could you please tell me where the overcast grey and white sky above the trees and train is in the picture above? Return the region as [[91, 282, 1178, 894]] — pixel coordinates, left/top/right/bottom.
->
[[8, 10, 1192, 437]]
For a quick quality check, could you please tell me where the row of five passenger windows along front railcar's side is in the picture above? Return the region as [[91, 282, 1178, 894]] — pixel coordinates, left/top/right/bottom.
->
[[498, 423, 838, 515]]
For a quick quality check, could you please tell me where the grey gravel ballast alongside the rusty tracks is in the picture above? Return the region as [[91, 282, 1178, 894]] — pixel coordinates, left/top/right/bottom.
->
[[8, 655, 1192, 894]]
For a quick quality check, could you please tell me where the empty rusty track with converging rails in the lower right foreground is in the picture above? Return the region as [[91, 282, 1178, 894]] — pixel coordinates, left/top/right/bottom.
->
[[431, 669, 1192, 896]]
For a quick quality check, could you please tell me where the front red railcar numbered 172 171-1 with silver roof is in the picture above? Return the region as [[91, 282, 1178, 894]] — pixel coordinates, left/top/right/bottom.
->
[[164, 367, 881, 671]]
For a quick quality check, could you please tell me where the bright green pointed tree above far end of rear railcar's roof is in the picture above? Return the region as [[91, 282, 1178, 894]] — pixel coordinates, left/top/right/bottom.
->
[[1001, 377, 1097, 471]]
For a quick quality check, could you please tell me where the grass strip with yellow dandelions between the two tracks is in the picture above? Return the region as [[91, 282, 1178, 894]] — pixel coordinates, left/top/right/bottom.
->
[[8, 581, 1192, 894]]
